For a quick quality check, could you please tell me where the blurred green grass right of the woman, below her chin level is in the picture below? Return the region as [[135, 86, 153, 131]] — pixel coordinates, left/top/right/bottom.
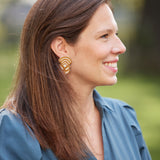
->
[[97, 75, 160, 160]]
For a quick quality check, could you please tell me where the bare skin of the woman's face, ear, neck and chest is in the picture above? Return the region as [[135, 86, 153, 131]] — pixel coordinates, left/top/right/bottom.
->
[[51, 4, 126, 160]]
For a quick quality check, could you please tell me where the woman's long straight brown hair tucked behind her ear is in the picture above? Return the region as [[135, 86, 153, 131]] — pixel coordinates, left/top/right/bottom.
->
[[5, 0, 107, 160]]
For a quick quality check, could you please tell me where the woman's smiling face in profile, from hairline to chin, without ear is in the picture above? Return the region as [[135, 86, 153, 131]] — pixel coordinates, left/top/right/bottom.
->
[[69, 4, 126, 87]]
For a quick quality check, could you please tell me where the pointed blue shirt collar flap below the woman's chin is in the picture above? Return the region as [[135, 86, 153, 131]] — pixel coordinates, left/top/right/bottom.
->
[[93, 90, 114, 111]]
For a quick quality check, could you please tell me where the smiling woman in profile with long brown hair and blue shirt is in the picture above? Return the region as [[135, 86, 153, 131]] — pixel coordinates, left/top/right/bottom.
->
[[0, 0, 150, 160]]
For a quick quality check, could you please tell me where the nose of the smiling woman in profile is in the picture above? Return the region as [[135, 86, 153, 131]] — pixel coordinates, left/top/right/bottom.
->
[[112, 37, 126, 54]]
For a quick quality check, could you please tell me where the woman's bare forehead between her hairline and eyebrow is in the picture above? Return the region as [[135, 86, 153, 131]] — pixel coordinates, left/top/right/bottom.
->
[[82, 3, 118, 34]]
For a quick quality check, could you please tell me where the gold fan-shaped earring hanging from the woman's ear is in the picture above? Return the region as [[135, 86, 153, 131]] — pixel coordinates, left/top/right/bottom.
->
[[58, 56, 72, 74]]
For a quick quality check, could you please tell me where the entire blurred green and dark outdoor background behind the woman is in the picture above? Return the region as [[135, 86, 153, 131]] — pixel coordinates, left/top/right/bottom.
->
[[0, 0, 160, 160]]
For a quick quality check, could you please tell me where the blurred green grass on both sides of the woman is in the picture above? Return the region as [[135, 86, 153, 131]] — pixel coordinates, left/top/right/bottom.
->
[[0, 48, 160, 160]]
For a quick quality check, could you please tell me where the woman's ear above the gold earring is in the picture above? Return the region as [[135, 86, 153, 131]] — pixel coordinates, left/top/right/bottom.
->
[[51, 36, 69, 57]]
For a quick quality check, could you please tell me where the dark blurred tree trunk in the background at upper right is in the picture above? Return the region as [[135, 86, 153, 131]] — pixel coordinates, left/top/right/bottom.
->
[[128, 0, 160, 74]]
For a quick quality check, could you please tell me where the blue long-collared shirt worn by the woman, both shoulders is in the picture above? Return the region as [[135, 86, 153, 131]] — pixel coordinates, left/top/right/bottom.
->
[[0, 91, 151, 160]]
